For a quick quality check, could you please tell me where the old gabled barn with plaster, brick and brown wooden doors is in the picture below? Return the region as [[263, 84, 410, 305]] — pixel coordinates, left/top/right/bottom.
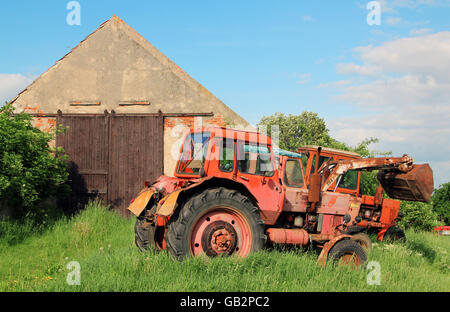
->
[[12, 16, 251, 215]]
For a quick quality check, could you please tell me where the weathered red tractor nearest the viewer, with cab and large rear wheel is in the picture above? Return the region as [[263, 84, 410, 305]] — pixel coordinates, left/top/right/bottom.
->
[[128, 128, 432, 265]]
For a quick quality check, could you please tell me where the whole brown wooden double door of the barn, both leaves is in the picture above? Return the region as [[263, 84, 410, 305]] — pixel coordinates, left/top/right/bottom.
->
[[56, 114, 164, 215]]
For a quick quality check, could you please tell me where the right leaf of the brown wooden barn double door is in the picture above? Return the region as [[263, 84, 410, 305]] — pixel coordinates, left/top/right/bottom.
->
[[108, 114, 164, 215]]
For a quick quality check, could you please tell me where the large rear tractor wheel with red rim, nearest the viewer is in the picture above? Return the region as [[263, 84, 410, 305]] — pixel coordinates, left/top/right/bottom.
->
[[166, 187, 266, 260]]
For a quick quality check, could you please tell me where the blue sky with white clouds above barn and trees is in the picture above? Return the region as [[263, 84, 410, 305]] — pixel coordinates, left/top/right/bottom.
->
[[0, 0, 450, 184]]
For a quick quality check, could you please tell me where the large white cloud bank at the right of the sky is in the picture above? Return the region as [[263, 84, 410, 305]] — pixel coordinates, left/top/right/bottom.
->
[[328, 31, 450, 186]]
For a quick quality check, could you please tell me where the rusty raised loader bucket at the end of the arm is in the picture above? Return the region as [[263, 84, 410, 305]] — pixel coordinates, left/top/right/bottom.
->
[[377, 164, 434, 202]]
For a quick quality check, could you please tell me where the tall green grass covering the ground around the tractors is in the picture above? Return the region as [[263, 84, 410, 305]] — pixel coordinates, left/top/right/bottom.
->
[[0, 204, 450, 292]]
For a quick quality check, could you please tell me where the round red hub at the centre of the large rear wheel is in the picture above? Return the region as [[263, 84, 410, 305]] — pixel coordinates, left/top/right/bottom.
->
[[202, 221, 237, 257]]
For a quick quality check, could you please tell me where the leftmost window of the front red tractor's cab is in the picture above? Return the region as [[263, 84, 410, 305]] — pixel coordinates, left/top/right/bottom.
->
[[177, 132, 210, 175]]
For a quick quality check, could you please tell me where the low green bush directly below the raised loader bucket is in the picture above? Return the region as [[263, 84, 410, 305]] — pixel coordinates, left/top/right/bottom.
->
[[400, 201, 440, 231]]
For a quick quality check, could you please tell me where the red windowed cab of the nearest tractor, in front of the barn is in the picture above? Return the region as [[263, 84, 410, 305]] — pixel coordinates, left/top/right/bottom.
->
[[174, 128, 276, 181]]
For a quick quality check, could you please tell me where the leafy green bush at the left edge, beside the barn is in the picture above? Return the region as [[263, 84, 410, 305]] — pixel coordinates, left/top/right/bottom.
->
[[0, 104, 68, 213]]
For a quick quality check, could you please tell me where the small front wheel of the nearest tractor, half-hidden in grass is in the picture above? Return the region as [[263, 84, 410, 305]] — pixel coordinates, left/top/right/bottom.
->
[[328, 239, 367, 266]]
